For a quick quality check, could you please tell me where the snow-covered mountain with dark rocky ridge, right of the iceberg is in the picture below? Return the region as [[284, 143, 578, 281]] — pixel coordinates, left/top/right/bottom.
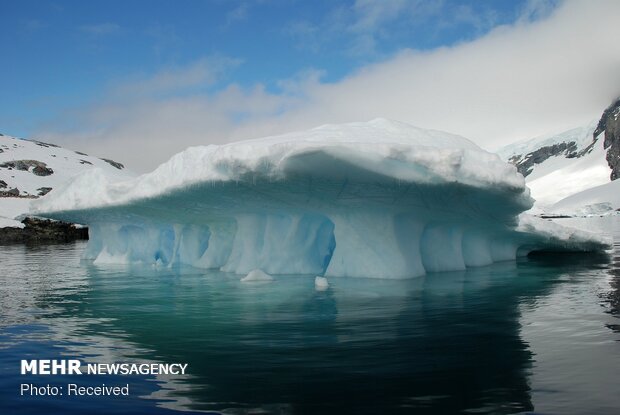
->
[[498, 99, 620, 213]]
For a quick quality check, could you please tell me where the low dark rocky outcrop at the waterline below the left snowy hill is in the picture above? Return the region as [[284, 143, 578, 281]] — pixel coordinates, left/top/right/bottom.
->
[[0, 218, 88, 244]]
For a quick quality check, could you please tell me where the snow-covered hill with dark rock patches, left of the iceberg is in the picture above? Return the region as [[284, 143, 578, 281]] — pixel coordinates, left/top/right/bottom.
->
[[0, 134, 134, 227]]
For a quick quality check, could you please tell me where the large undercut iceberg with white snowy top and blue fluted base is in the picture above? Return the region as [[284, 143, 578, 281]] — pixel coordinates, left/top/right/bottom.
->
[[33, 119, 608, 278]]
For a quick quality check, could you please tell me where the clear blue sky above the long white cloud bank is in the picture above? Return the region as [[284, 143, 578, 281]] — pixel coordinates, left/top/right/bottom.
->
[[0, 0, 525, 136]]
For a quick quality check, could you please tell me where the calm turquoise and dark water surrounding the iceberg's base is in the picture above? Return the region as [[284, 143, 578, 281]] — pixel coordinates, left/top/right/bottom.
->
[[0, 219, 620, 414]]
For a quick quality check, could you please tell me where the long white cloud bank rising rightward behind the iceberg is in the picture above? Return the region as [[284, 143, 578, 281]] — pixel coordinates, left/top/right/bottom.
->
[[38, 0, 620, 170]]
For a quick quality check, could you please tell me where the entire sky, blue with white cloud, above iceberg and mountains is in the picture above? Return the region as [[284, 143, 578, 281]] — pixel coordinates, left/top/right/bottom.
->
[[0, 0, 620, 172]]
